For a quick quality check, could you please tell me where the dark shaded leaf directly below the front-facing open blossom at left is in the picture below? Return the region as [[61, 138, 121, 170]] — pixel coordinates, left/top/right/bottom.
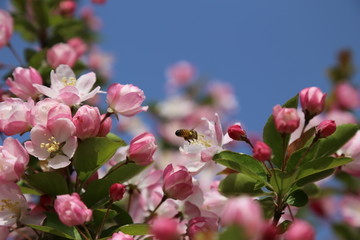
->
[[26, 172, 69, 196]]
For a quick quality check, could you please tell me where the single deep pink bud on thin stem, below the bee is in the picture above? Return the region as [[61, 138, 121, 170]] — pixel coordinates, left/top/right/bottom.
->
[[163, 164, 193, 200]]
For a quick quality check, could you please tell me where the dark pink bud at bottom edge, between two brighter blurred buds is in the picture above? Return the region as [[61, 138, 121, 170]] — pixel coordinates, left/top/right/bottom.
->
[[187, 217, 218, 239]]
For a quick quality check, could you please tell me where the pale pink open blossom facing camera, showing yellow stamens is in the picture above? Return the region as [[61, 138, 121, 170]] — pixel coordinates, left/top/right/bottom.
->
[[25, 118, 77, 169]]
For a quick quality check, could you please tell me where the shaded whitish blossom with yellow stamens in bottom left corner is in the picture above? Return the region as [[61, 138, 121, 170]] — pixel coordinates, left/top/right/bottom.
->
[[0, 182, 27, 227]]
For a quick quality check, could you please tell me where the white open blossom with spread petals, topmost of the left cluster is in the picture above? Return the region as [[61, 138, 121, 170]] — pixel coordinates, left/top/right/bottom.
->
[[34, 65, 101, 106]]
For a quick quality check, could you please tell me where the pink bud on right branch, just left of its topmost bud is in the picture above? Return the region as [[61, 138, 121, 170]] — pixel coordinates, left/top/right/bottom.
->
[[273, 105, 300, 134]]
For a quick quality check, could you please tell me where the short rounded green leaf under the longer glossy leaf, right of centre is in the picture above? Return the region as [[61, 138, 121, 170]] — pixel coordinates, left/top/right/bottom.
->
[[219, 173, 264, 197]]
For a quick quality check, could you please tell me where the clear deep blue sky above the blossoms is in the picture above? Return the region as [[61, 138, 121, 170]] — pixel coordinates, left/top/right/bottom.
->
[[0, 0, 360, 131]]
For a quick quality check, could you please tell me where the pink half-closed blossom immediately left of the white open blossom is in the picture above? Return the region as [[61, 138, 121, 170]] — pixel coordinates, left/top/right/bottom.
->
[[6, 67, 43, 100]]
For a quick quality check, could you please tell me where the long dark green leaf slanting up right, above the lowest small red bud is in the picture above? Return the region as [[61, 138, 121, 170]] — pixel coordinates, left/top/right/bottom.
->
[[82, 163, 146, 207]]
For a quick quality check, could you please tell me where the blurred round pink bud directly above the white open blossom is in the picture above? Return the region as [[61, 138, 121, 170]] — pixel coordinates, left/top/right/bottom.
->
[[46, 43, 77, 68]]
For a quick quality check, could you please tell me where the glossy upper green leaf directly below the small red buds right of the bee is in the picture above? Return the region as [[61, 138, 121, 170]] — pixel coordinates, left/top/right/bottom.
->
[[213, 151, 270, 186]]
